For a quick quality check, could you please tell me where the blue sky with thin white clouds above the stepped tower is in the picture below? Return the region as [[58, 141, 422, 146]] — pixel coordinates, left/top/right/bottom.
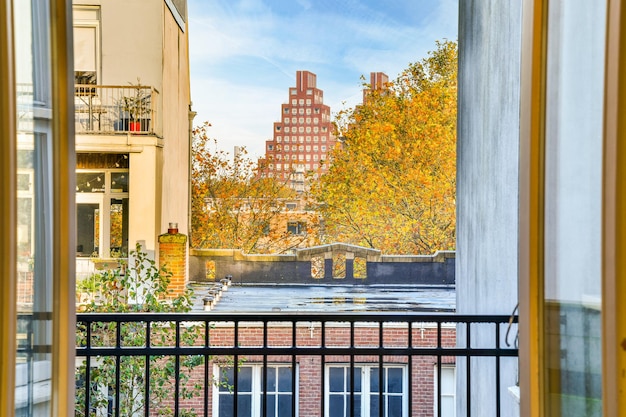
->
[[188, 0, 458, 158]]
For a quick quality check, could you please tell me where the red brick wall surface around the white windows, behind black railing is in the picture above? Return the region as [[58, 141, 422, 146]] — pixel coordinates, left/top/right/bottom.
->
[[158, 323, 456, 417]]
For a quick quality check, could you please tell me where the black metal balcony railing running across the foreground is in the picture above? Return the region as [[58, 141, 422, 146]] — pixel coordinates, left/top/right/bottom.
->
[[76, 312, 518, 417]]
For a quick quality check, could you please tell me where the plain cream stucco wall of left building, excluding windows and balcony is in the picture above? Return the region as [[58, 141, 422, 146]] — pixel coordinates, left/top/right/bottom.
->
[[74, 0, 191, 256]]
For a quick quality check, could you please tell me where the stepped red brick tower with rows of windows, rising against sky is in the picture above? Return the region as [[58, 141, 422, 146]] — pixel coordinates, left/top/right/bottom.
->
[[259, 71, 336, 192]]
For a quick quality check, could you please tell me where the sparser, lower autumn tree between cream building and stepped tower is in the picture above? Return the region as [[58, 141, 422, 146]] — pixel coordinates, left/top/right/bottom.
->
[[191, 123, 320, 253]]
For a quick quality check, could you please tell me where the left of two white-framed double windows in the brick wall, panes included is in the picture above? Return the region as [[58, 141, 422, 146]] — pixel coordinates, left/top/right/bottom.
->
[[213, 364, 298, 417]]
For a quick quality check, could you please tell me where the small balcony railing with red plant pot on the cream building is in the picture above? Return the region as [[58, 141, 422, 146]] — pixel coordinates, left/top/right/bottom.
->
[[74, 84, 159, 134]]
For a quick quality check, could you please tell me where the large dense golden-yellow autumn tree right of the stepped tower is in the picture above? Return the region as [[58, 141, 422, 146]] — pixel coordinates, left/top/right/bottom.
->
[[314, 41, 457, 254]]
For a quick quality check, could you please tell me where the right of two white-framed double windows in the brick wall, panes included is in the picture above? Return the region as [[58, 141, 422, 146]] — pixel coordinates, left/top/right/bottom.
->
[[324, 364, 408, 417]]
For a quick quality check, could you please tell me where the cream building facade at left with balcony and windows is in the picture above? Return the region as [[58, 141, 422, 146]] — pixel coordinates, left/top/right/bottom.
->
[[72, 0, 193, 278]]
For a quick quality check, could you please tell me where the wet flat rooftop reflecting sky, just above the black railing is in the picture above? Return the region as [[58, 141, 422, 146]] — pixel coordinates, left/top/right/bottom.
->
[[192, 283, 456, 313]]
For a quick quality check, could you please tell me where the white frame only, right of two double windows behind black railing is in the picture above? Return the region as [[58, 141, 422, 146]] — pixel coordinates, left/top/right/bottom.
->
[[324, 363, 409, 417]]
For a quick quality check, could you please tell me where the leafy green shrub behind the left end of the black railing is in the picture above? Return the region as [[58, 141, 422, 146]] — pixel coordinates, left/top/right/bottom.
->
[[75, 244, 204, 416]]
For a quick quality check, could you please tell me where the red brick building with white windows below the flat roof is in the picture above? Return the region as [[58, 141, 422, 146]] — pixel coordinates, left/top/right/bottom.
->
[[168, 323, 456, 417]]
